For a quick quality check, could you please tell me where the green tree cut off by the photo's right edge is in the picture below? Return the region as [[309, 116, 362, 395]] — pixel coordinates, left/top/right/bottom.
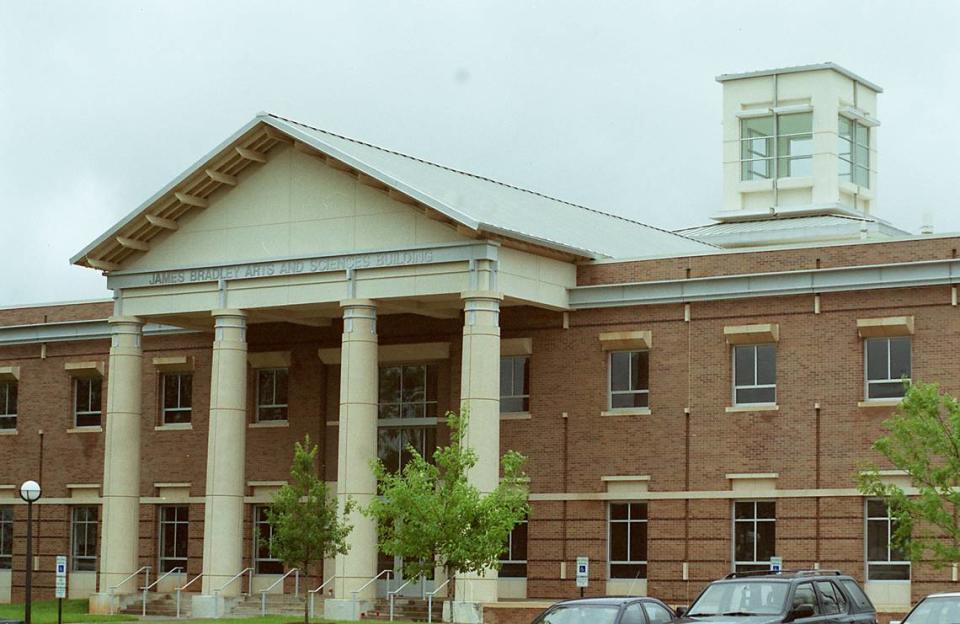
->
[[858, 383, 960, 567]]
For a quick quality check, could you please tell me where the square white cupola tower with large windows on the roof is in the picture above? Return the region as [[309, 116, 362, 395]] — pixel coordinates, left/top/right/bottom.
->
[[714, 63, 883, 222]]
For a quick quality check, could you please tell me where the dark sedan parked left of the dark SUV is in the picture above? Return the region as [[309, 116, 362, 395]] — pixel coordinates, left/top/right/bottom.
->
[[532, 597, 676, 624]]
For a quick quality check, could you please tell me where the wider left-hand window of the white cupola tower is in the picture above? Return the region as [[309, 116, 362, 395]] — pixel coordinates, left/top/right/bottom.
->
[[740, 113, 813, 180]]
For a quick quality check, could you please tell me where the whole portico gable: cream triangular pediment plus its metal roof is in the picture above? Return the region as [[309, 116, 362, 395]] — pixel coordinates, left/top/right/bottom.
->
[[71, 114, 713, 271]]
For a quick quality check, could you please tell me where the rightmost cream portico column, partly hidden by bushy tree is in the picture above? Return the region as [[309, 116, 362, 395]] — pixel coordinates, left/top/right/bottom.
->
[[457, 290, 502, 602]]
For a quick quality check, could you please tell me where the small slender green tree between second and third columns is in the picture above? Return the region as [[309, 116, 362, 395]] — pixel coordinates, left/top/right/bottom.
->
[[267, 435, 354, 624]]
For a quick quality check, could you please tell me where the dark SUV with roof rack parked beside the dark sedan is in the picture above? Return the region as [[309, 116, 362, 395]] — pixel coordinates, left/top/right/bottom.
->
[[684, 570, 877, 624]]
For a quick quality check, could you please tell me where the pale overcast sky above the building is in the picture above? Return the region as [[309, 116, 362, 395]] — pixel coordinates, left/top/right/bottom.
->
[[0, 0, 960, 305]]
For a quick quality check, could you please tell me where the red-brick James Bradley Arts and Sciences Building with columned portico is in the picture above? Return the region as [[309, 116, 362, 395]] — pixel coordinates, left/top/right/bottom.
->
[[0, 64, 960, 617]]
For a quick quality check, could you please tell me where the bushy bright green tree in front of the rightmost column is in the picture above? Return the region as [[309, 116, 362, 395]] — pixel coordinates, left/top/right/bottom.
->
[[365, 411, 530, 604]]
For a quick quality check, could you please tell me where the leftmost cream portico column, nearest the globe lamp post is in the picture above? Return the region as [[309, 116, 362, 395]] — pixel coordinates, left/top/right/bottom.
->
[[90, 317, 143, 613]]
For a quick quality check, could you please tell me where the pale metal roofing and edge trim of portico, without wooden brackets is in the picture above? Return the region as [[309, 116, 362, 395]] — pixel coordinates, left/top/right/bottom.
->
[[71, 113, 717, 265]]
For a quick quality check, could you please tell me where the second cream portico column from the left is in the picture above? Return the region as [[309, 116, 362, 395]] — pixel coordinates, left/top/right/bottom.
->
[[193, 310, 247, 617]]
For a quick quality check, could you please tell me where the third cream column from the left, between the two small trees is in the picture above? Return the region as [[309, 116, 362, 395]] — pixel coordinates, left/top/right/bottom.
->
[[324, 299, 379, 619]]
